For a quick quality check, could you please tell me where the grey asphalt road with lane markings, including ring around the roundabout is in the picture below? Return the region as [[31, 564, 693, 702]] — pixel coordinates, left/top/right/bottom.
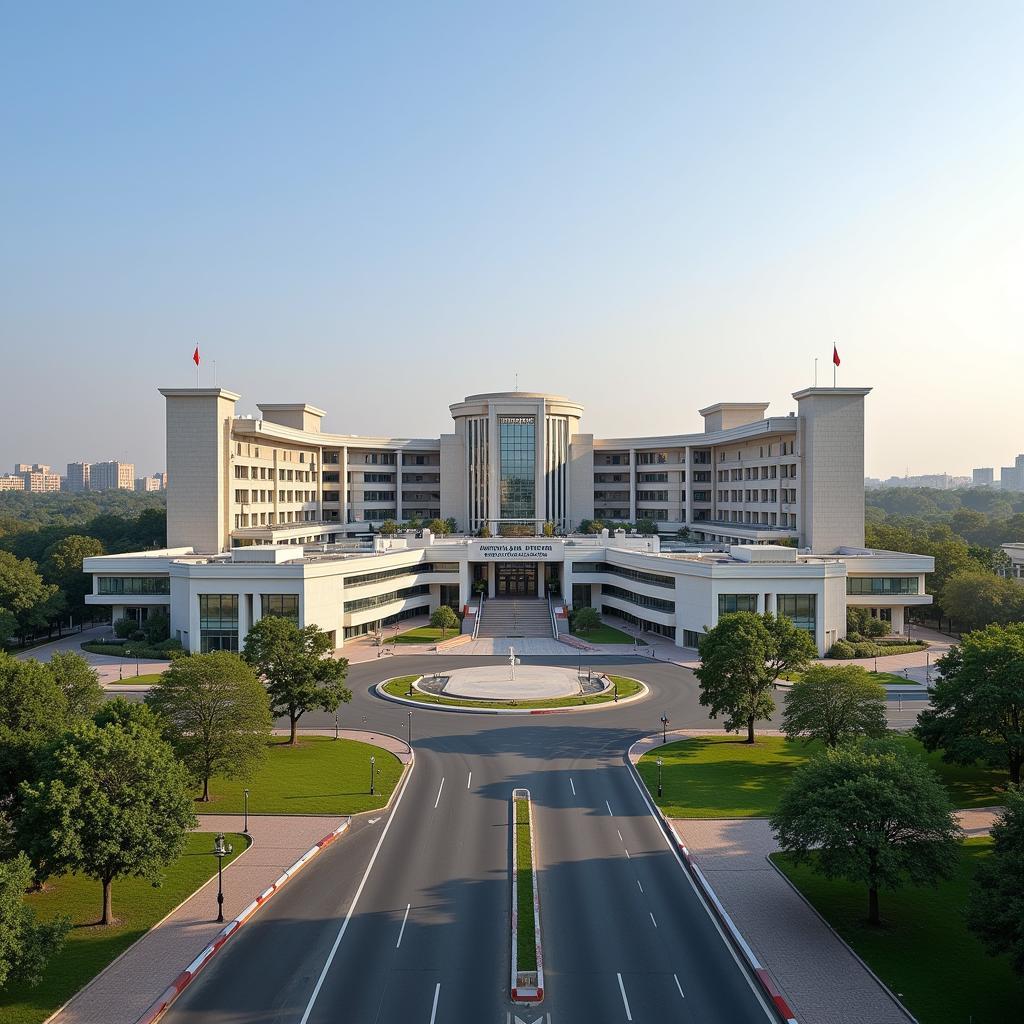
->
[[159, 656, 775, 1024]]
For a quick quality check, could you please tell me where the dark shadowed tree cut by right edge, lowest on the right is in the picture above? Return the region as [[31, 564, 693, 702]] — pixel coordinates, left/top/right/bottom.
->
[[967, 786, 1024, 975]]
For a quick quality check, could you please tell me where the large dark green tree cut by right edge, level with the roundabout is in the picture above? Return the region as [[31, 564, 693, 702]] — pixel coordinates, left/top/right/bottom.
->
[[914, 623, 1024, 783]]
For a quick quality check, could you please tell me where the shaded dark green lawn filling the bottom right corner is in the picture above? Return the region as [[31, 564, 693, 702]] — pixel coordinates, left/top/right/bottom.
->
[[771, 838, 1024, 1024]]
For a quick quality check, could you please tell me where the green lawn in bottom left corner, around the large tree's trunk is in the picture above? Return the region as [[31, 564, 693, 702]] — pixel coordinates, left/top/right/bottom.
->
[[0, 833, 247, 1024]]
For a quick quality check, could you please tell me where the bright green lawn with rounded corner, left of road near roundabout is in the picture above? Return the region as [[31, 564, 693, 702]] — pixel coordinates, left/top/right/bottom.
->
[[196, 733, 401, 814]]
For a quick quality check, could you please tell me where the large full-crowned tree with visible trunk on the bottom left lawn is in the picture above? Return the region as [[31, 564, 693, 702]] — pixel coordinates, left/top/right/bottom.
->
[[20, 722, 196, 925]]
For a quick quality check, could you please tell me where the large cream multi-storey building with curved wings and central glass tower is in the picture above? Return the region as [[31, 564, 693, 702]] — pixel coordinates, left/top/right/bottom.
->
[[85, 388, 933, 651]]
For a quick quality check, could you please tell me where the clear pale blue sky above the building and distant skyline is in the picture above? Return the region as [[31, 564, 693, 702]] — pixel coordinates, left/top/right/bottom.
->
[[0, 0, 1024, 475]]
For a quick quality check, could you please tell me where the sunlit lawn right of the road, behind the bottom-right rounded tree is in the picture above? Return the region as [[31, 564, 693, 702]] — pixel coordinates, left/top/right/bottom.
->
[[639, 735, 1008, 818]]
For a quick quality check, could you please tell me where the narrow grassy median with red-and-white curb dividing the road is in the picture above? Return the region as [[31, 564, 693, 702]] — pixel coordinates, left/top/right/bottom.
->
[[511, 790, 544, 1002]]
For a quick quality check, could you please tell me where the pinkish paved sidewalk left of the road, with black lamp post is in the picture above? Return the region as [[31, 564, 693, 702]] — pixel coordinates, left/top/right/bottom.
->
[[51, 814, 343, 1024]]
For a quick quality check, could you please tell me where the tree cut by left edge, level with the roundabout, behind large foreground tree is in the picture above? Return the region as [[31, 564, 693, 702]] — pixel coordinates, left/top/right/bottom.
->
[[0, 652, 68, 806]]
